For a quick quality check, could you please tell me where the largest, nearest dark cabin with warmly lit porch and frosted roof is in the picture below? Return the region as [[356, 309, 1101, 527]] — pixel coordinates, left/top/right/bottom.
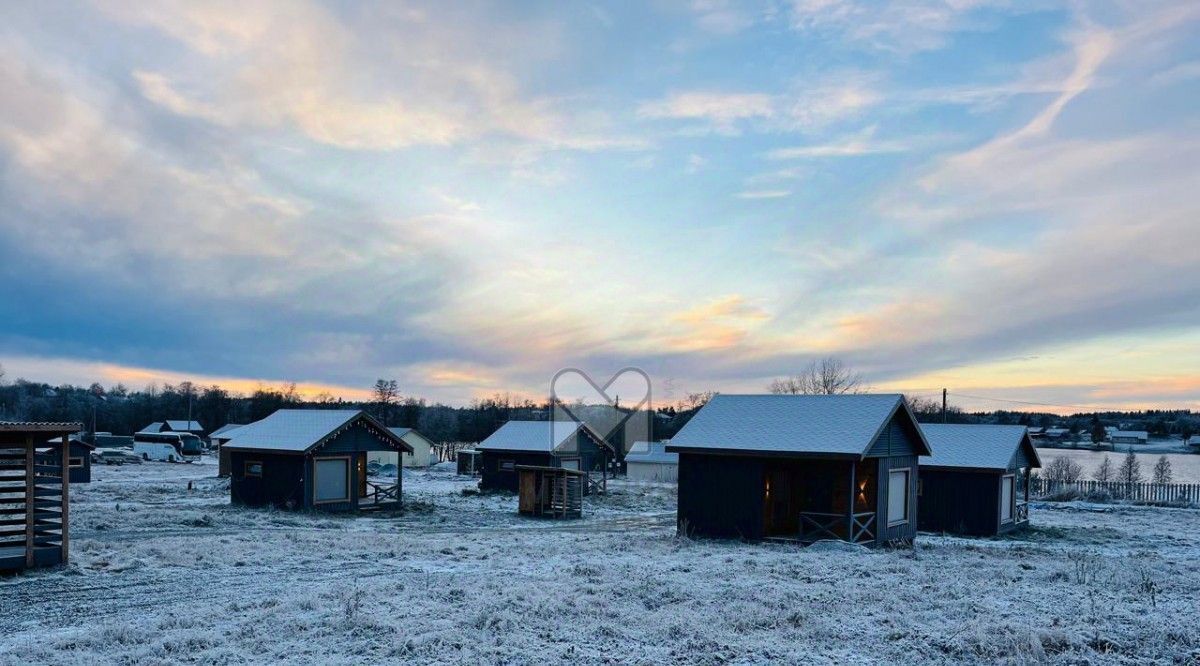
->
[[666, 395, 930, 546]]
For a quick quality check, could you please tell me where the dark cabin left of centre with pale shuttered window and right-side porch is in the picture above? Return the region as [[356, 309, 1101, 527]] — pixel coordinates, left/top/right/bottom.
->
[[222, 409, 412, 511]]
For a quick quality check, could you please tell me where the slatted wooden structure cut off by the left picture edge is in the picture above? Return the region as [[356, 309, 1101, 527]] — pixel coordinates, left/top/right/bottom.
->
[[0, 421, 83, 572]]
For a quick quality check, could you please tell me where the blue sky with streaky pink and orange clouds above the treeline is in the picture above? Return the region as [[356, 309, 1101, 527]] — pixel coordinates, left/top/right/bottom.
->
[[0, 0, 1200, 412]]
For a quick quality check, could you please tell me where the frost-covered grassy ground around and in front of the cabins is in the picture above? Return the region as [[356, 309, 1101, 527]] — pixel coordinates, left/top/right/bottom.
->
[[0, 463, 1200, 666]]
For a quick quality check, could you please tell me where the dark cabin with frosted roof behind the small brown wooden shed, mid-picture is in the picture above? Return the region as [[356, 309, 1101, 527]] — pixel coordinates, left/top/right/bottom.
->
[[475, 421, 612, 492]]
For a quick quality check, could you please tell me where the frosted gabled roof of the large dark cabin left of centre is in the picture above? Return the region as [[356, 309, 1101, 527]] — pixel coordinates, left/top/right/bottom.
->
[[224, 409, 413, 454]]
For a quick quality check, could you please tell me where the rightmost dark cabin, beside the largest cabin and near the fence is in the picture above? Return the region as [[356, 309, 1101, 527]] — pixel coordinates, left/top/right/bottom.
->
[[918, 424, 1042, 536]]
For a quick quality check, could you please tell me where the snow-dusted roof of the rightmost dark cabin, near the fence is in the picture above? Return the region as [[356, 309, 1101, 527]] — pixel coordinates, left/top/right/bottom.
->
[[920, 424, 1042, 470]]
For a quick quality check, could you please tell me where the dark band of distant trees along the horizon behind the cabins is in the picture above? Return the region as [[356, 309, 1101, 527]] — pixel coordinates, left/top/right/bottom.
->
[[0, 368, 1200, 442]]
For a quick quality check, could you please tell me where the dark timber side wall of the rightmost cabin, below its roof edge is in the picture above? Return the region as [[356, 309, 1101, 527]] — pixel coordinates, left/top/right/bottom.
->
[[919, 468, 1001, 536]]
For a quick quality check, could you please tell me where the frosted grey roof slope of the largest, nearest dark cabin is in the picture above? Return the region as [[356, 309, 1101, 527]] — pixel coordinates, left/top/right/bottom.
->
[[667, 394, 924, 456]]
